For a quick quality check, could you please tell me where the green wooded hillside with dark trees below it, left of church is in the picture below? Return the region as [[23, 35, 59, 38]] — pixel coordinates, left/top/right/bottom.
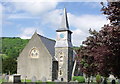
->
[[0, 37, 29, 74]]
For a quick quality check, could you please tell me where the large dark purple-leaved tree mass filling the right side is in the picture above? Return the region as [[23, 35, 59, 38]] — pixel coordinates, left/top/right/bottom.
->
[[77, 1, 120, 81]]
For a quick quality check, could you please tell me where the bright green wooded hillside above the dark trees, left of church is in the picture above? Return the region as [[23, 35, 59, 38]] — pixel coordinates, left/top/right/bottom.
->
[[0, 37, 29, 58]]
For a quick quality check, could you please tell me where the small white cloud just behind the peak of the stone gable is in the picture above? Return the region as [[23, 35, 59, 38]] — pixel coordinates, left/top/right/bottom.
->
[[18, 27, 44, 39]]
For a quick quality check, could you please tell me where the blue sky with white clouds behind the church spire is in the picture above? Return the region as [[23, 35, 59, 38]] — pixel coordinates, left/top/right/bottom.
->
[[0, 0, 108, 46]]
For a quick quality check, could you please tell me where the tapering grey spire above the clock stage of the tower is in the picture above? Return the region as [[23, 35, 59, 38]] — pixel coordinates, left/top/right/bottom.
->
[[60, 8, 69, 30]]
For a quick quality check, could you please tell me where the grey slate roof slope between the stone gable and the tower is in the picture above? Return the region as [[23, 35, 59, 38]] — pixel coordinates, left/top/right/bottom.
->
[[38, 34, 56, 58]]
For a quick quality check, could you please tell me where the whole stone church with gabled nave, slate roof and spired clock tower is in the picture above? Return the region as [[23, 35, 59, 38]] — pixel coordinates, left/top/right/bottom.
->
[[17, 8, 75, 82]]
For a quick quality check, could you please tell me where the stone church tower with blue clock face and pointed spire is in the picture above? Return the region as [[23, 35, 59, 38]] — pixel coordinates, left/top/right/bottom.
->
[[55, 8, 73, 82]]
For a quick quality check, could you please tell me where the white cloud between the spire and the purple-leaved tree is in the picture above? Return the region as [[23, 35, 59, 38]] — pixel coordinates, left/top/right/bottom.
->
[[68, 13, 108, 46]]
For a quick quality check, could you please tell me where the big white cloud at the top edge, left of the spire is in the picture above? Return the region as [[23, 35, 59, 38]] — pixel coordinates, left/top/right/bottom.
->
[[13, 2, 57, 15]]
